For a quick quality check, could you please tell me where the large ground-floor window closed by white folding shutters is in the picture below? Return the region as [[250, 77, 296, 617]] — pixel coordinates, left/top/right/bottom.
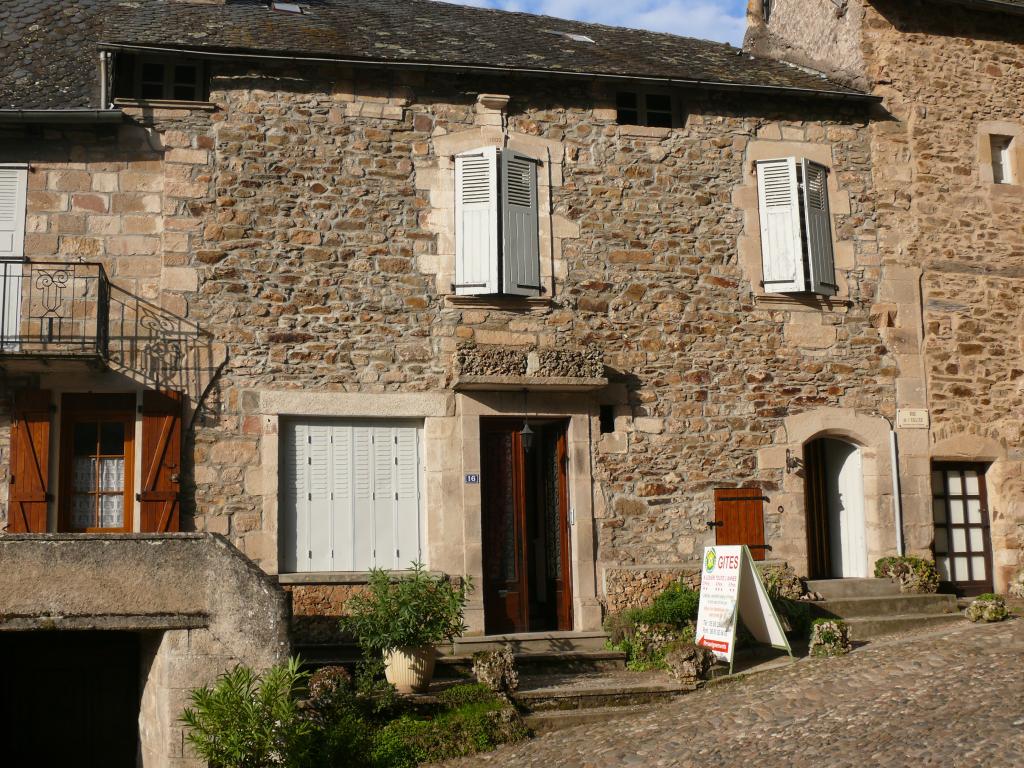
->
[[280, 419, 422, 572]]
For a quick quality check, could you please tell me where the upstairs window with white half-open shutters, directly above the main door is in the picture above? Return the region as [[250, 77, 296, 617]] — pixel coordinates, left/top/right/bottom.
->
[[454, 146, 544, 296]]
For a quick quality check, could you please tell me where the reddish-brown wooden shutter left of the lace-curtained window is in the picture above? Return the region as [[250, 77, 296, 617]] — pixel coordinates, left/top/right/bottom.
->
[[7, 389, 52, 534]]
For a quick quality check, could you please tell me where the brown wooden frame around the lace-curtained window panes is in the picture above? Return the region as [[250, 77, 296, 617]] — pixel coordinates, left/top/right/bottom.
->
[[57, 394, 137, 534]]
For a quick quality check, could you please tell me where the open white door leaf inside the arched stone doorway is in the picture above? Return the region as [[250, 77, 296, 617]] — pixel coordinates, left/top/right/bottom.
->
[[825, 440, 867, 579]]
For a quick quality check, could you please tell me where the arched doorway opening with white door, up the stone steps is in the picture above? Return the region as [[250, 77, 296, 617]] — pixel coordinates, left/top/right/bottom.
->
[[804, 437, 867, 579]]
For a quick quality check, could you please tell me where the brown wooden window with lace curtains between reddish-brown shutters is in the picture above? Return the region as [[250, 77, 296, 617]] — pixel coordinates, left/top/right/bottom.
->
[[60, 394, 135, 532]]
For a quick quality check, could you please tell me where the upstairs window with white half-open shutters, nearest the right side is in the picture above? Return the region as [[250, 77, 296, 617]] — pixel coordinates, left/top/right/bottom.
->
[[757, 158, 838, 296]]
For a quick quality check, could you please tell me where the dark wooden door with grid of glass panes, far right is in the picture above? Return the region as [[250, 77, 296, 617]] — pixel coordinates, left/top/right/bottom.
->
[[932, 463, 992, 597]]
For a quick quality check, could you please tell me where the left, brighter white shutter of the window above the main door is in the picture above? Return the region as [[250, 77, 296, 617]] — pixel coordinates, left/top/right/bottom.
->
[[455, 146, 498, 296]]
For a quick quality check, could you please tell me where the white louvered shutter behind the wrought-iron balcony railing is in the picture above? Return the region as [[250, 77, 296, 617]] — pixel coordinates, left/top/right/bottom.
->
[[0, 166, 29, 351]]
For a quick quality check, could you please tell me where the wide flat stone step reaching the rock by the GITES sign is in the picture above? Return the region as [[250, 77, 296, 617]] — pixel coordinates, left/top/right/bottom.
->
[[513, 672, 697, 713]]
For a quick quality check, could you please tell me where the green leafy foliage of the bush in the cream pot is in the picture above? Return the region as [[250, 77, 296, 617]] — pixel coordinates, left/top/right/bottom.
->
[[341, 562, 472, 653]]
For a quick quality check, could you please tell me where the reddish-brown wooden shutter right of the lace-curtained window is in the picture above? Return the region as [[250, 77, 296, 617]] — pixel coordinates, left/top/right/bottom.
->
[[138, 391, 182, 534]]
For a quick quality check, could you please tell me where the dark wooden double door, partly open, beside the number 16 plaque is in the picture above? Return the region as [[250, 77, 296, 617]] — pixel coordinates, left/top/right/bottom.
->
[[480, 419, 572, 634]]
